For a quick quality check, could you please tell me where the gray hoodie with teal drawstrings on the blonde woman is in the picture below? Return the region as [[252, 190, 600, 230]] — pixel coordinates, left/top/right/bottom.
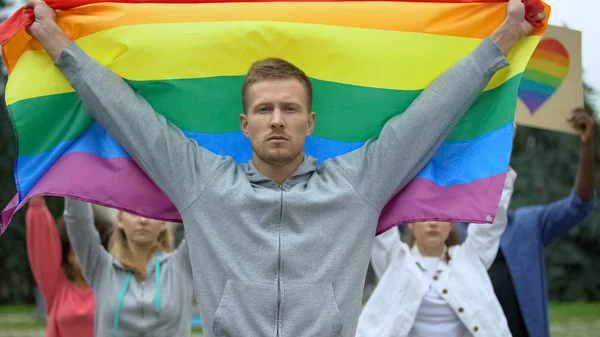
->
[[64, 199, 194, 337]]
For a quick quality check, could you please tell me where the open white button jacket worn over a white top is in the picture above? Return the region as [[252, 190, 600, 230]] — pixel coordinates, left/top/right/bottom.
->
[[356, 169, 516, 337]]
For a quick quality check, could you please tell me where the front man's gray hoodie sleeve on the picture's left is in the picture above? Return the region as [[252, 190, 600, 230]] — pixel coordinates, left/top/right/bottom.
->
[[56, 43, 226, 212]]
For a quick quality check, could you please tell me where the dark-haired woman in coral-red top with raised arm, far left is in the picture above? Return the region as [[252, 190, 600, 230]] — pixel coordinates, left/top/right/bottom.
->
[[26, 197, 113, 337]]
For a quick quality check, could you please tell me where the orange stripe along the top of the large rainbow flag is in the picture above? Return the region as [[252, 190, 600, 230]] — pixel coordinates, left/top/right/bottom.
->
[[3, 1, 552, 74]]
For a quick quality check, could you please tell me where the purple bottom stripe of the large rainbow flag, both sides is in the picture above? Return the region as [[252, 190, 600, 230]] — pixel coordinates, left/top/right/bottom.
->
[[0, 152, 505, 234]]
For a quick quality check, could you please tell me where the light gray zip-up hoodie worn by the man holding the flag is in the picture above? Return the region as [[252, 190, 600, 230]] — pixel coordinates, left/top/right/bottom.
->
[[56, 39, 508, 337]]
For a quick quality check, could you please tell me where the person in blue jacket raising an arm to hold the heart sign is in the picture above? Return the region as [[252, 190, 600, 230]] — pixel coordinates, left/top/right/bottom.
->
[[488, 109, 596, 337]]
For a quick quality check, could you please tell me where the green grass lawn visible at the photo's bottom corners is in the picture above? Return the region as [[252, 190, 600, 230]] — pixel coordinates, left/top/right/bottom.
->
[[0, 302, 600, 337]]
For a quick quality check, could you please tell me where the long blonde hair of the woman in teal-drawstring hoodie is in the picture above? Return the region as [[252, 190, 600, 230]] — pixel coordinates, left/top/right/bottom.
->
[[110, 211, 173, 278]]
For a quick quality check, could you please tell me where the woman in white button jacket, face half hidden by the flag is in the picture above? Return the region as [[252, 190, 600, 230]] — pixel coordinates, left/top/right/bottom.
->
[[357, 169, 516, 337]]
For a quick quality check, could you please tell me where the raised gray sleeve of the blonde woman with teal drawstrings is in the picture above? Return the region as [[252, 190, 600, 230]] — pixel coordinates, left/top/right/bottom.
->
[[64, 198, 113, 288]]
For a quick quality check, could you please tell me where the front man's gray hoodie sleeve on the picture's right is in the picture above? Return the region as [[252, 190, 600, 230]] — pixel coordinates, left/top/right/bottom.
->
[[333, 38, 508, 212]]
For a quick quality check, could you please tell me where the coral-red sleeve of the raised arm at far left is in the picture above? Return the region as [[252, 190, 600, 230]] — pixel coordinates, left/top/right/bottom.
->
[[25, 197, 69, 311]]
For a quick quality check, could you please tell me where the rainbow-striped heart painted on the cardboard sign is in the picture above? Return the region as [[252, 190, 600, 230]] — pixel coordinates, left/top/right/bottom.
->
[[519, 39, 569, 115]]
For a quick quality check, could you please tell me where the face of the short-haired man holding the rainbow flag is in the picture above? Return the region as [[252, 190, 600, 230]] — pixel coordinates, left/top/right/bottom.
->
[[240, 79, 315, 166]]
